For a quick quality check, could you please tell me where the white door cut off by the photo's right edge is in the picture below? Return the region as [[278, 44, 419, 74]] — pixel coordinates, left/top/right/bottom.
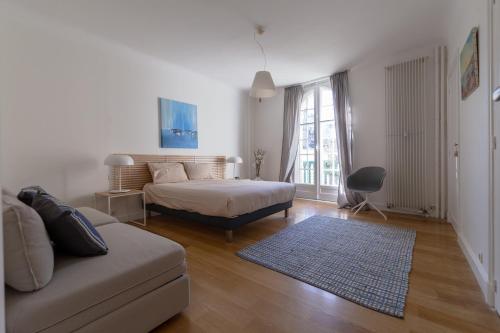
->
[[492, 1, 500, 313]]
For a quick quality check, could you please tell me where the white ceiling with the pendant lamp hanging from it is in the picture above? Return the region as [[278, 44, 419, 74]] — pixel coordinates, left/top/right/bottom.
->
[[9, 0, 453, 88]]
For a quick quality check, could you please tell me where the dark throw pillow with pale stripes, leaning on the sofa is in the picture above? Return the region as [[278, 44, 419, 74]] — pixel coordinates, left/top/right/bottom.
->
[[32, 194, 108, 256]]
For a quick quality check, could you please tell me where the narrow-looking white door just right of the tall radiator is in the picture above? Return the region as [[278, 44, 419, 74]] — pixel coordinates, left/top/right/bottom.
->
[[446, 53, 461, 233]]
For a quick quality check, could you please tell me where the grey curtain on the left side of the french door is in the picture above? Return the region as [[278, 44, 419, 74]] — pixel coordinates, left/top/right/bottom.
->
[[280, 86, 304, 183]]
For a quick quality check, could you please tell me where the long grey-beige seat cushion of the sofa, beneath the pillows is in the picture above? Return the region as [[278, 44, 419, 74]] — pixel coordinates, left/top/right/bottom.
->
[[5, 223, 185, 332]]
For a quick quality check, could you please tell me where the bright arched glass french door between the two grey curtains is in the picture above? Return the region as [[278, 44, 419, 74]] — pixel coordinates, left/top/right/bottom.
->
[[294, 81, 340, 201]]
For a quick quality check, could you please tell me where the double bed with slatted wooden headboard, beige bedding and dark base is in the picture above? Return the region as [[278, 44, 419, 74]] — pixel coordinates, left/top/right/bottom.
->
[[115, 154, 295, 241]]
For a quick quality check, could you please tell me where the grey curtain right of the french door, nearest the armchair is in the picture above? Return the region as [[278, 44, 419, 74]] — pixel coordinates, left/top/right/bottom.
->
[[330, 71, 362, 208]]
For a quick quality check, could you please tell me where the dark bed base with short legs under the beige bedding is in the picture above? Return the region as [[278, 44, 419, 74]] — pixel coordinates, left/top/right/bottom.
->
[[146, 201, 292, 242]]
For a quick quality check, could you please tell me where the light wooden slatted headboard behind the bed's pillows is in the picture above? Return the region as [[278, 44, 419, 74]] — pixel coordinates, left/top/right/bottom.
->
[[111, 154, 226, 190]]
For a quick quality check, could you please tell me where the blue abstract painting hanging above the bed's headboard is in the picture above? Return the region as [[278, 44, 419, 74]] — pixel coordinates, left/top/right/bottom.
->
[[159, 98, 198, 149]]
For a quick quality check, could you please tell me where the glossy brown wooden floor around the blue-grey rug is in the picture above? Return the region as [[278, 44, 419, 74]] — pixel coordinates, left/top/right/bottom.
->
[[139, 200, 500, 333]]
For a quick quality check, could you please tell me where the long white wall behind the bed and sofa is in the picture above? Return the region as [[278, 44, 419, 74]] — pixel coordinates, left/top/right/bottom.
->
[[0, 10, 247, 210]]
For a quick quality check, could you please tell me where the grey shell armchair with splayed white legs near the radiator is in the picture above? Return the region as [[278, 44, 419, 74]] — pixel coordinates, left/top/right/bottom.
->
[[346, 167, 387, 221]]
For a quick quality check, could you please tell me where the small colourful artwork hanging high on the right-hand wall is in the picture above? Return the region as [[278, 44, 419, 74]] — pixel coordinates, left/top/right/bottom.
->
[[460, 27, 479, 100]]
